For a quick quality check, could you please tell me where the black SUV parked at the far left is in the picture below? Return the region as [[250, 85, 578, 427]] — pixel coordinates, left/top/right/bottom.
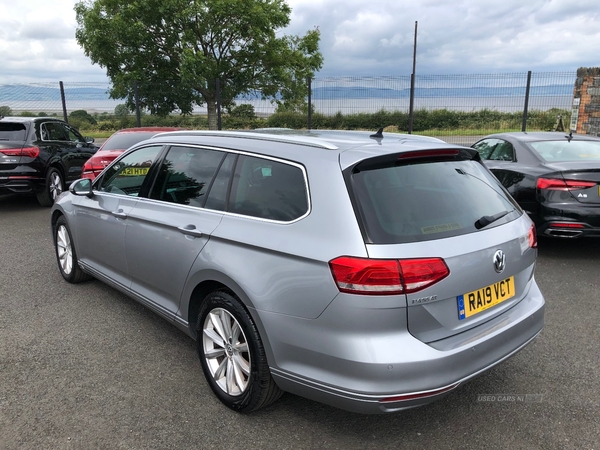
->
[[0, 116, 98, 206]]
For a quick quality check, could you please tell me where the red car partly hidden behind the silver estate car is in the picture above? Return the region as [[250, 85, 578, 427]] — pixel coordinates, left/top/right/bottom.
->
[[81, 127, 182, 180]]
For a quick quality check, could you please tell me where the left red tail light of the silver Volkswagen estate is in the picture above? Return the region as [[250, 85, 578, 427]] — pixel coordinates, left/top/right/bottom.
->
[[329, 256, 450, 295]]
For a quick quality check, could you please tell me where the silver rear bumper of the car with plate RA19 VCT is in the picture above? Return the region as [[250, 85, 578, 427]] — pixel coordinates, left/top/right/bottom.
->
[[261, 280, 545, 413]]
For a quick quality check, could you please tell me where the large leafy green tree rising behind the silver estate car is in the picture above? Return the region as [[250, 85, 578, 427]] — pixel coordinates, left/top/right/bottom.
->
[[75, 0, 323, 129]]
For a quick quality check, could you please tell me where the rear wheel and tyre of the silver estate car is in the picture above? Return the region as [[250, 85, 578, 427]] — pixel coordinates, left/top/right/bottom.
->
[[197, 291, 283, 413]]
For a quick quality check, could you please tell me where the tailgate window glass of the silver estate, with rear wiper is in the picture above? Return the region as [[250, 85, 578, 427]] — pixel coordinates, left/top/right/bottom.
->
[[351, 161, 521, 244]]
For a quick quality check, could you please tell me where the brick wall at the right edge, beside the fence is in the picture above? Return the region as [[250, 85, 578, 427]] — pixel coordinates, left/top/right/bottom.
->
[[573, 67, 600, 136]]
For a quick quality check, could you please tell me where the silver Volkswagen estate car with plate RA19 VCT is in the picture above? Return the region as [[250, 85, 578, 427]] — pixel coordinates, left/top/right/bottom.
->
[[51, 130, 544, 413]]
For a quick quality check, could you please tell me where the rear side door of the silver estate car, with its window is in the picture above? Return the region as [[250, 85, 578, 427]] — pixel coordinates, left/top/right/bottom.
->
[[125, 146, 226, 315]]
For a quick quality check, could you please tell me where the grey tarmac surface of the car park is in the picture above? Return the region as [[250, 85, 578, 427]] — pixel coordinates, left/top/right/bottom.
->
[[0, 192, 600, 450]]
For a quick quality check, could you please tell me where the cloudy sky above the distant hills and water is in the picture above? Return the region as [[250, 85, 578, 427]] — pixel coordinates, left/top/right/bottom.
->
[[0, 0, 600, 83]]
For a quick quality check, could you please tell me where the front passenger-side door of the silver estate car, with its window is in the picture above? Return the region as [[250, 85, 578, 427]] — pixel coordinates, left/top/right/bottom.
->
[[74, 145, 162, 288]]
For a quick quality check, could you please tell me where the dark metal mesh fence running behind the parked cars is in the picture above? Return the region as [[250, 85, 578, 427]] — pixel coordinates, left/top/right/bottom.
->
[[0, 72, 577, 144]]
